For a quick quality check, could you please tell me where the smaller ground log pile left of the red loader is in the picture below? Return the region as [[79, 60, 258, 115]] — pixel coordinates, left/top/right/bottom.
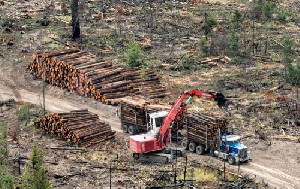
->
[[35, 110, 115, 147]]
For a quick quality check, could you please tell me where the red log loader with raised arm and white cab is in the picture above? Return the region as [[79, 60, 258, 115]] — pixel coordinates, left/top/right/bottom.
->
[[129, 89, 230, 162]]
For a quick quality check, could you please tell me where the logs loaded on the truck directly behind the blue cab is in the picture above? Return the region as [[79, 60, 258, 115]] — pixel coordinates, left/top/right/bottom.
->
[[186, 113, 228, 144]]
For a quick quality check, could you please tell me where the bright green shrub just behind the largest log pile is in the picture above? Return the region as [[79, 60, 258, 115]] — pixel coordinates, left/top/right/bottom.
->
[[126, 42, 144, 67]]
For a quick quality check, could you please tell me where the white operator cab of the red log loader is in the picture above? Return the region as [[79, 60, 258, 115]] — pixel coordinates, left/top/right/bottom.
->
[[148, 111, 168, 135]]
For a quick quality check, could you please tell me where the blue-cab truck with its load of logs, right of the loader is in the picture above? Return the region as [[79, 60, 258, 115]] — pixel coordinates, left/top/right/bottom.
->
[[182, 113, 250, 165]]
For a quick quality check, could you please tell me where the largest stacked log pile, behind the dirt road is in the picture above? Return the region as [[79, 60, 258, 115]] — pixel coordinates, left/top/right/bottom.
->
[[28, 49, 168, 104]]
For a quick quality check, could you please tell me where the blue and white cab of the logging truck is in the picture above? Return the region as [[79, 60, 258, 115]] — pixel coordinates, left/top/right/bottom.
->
[[214, 135, 250, 165]]
